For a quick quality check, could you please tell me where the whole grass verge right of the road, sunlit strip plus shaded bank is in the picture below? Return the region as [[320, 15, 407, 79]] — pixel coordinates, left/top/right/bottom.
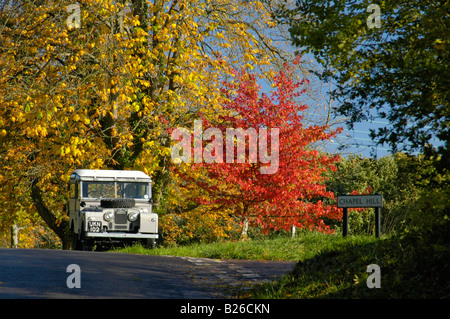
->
[[110, 232, 450, 299]]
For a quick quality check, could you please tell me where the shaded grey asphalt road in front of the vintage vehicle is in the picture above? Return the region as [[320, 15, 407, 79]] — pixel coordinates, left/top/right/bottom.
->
[[0, 249, 295, 299]]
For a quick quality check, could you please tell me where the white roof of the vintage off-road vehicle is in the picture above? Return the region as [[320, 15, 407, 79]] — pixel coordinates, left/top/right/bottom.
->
[[70, 169, 151, 182]]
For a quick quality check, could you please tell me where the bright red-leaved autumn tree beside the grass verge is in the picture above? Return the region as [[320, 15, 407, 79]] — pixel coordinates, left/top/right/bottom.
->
[[172, 59, 341, 237]]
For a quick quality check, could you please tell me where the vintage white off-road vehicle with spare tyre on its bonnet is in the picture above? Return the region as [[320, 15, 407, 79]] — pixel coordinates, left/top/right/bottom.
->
[[69, 169, 158, 250]]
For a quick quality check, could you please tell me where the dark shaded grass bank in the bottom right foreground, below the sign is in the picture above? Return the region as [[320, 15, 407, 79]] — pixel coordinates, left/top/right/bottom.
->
[[243, 232, 450, 299]]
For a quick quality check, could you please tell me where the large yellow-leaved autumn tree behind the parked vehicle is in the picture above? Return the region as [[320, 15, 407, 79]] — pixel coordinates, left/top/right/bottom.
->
[[0, 0, 290, 248]]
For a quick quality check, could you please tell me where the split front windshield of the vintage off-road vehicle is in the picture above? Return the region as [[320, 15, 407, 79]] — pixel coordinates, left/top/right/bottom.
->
[[83, 182, 149, 199]]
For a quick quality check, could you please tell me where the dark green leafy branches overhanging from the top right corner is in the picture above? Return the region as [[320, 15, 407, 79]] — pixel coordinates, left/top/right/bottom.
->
[[284, 0, 450, 167]]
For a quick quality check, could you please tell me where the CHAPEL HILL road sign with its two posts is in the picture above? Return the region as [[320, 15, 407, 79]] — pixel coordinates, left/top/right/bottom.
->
[[337, 194, 383, 237]]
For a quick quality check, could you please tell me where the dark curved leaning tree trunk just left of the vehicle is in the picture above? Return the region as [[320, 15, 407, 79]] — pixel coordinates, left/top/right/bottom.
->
[[31, 179, 72, 249]]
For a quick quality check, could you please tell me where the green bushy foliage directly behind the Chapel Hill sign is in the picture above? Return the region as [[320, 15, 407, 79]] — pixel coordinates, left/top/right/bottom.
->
[[327, 153, 444, 234]]
